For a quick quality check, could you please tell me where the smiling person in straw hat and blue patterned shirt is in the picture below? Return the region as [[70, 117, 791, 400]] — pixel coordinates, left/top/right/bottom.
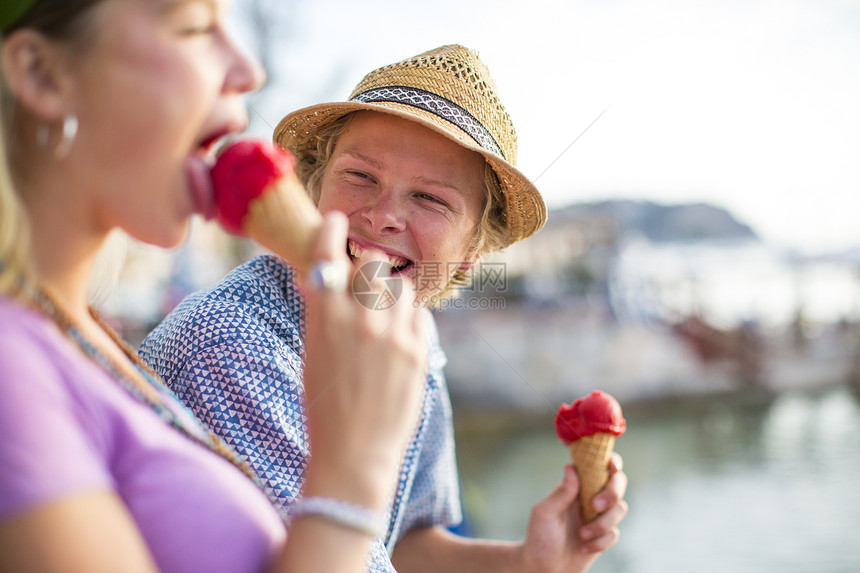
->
[[141, 45, 627, 573]]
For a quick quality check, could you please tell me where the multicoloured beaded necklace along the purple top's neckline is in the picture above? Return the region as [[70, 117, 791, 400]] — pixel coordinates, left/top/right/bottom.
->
[[33, 290, 272, 499]]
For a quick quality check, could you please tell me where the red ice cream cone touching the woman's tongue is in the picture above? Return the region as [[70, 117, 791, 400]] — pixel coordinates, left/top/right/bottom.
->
[[210, 139, 322, 272]]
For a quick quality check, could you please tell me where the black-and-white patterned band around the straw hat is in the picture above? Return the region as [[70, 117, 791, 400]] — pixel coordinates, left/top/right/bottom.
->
[[350, 86, 507, 159]]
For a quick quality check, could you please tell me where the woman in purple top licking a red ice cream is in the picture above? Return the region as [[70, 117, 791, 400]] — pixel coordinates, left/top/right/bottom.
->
[[0, 0, 424, 573]]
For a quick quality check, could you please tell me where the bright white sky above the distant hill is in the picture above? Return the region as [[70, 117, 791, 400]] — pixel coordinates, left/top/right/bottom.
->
[[235, 0, 860, 254]]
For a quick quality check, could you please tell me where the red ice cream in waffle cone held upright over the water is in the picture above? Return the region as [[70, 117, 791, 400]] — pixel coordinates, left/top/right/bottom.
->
[[555, 390, 627, 523]]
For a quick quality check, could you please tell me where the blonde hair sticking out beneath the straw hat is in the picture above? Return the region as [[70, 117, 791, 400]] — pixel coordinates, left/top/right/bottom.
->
[[296, 112, 507, 298]]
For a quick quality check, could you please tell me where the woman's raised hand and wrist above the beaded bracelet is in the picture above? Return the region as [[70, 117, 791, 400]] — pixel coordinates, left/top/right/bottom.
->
[[303, 212, 427, 510]]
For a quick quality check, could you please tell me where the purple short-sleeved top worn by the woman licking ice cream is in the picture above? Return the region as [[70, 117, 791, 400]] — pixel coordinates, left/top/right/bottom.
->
[[0, 297, 286, 572]]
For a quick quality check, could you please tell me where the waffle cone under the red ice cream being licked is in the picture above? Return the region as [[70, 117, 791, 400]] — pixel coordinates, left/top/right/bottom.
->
[[242, 175, 322, 272]]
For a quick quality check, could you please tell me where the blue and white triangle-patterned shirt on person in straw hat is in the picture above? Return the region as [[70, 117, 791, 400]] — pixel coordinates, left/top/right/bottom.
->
[[140, 255, 461, 573]]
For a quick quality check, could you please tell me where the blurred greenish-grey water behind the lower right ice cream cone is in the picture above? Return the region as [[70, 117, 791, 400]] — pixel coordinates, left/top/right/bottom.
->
[[450, 388, 860, 573]]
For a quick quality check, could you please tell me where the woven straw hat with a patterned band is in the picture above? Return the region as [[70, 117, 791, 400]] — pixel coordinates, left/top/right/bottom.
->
[[274, 45, 546, 247]]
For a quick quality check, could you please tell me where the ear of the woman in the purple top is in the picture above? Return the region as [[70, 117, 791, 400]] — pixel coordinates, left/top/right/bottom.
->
[[0, 29, 71, 122]]
